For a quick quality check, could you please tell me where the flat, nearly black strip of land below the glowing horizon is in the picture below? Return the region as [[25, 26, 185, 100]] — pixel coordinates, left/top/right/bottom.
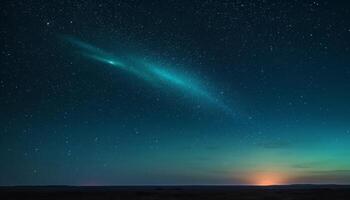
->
[[0, 185, 350, 200]]
